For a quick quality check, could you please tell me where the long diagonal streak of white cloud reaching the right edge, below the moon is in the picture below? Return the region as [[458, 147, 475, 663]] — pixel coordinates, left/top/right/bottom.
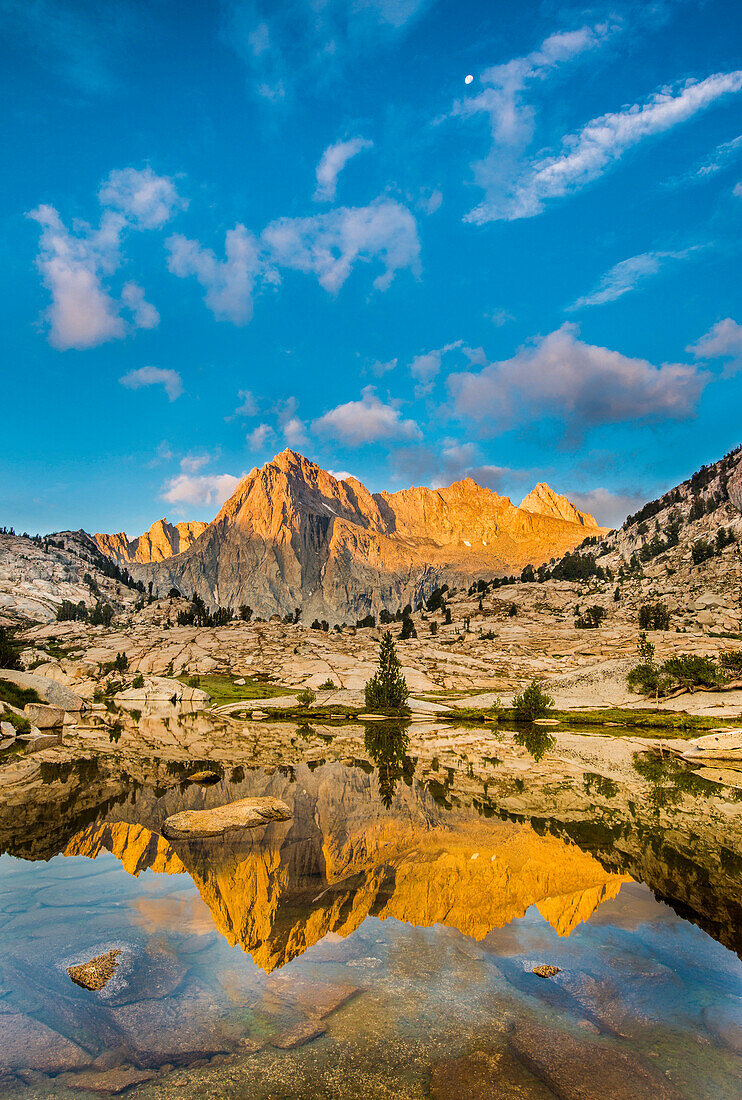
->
[[466, 70, 742, 224]]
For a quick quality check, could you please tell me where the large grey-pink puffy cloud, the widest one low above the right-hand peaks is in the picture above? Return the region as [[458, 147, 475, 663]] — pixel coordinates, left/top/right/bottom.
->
[[448, 325, 710, 433]]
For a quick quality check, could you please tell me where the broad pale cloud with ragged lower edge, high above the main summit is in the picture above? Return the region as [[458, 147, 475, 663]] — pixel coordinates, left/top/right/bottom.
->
[[262, 198, 420, 294]]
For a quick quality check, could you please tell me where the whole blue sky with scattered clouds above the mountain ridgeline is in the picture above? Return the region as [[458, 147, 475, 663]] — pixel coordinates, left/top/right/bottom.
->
[[0, 0, 742, 535]]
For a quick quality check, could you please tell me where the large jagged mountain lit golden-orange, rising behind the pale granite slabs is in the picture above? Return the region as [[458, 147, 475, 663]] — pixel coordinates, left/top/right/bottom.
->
[[137, 451, 601, 622]]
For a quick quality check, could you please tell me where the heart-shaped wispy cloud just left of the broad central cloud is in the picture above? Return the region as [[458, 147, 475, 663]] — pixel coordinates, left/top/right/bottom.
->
[[165, 224, 262, 325]]
